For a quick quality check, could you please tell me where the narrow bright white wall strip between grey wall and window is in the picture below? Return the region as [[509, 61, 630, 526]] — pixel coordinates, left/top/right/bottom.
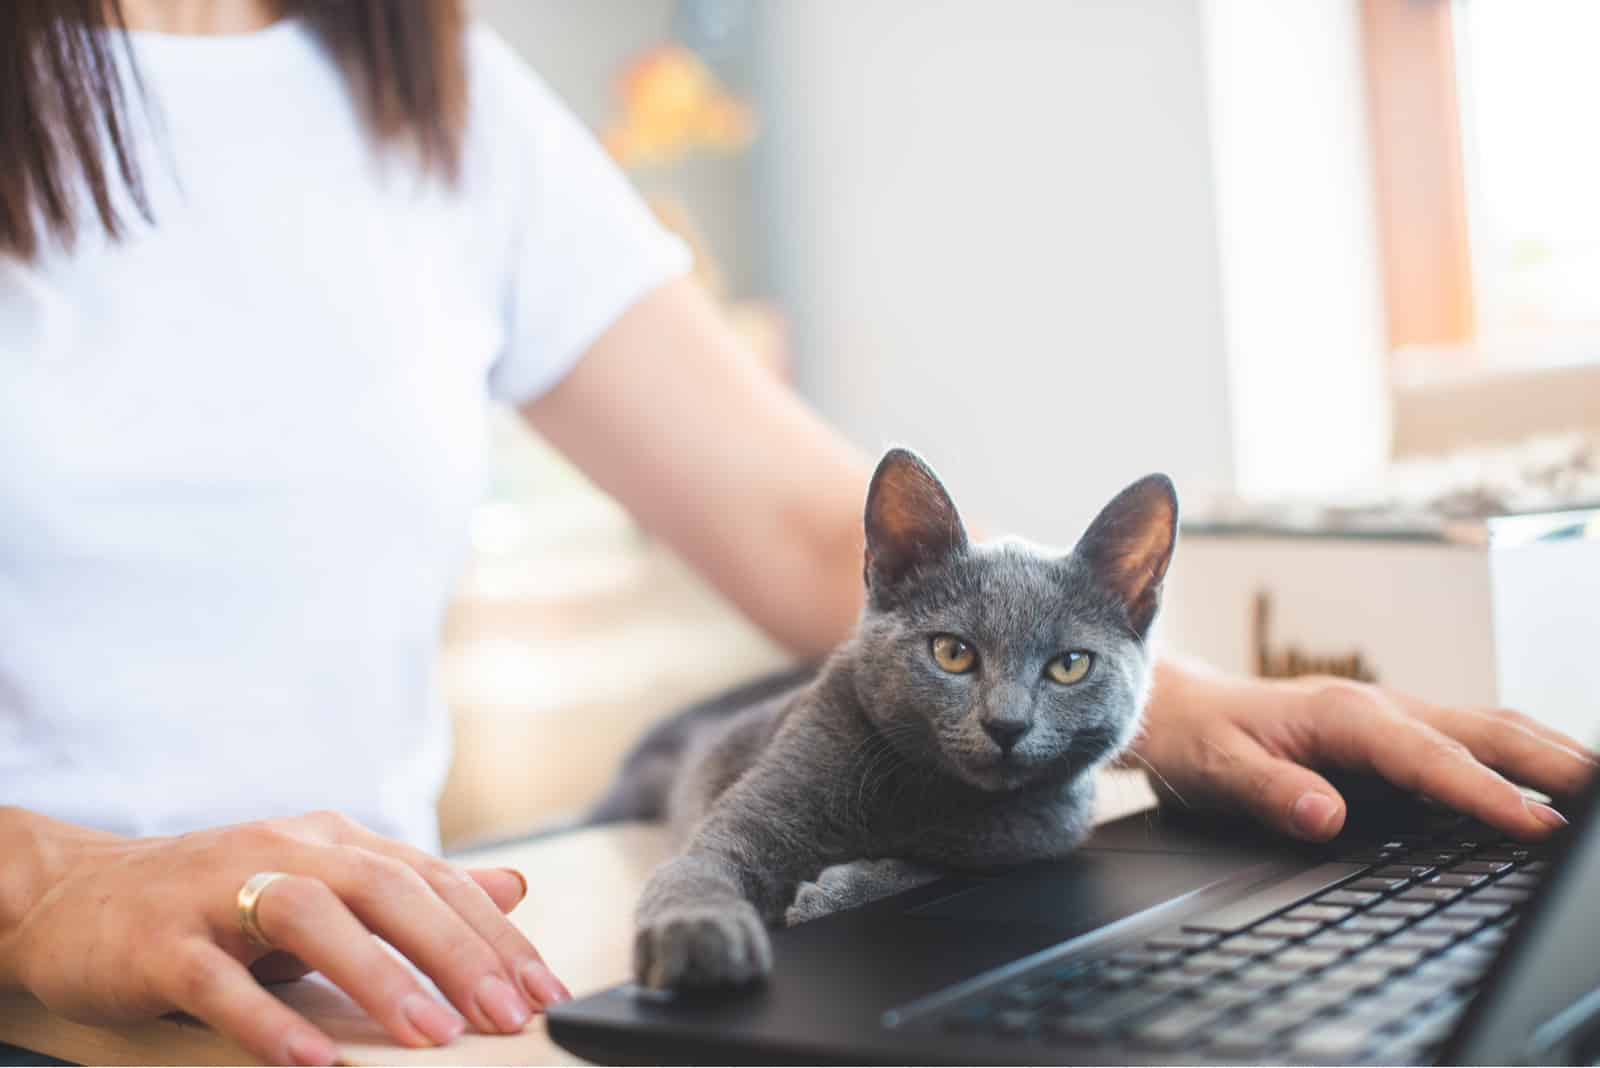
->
[[1203, 0, 1390, 497]]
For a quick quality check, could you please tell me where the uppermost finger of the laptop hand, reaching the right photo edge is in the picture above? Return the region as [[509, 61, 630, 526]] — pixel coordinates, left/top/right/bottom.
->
[[1406, 702, 1595, 796]]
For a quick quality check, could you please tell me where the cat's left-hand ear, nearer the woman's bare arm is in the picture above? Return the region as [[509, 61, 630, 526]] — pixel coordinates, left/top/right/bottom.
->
[[866, 449, 966, 592]]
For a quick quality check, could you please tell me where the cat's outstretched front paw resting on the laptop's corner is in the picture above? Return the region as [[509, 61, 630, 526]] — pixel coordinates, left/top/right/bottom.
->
[[634, 902, 773, 990]]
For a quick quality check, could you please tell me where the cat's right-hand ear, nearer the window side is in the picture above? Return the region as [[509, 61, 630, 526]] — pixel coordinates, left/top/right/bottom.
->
[[1072, 475, 1178, 638]]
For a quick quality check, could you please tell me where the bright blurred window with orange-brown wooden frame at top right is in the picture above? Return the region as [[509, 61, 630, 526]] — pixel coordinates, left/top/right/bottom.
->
[[1362, 0, 1600, 384]]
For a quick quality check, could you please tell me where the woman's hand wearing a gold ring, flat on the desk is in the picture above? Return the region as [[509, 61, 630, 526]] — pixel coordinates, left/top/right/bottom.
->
[[0, 814, 570, 1065]]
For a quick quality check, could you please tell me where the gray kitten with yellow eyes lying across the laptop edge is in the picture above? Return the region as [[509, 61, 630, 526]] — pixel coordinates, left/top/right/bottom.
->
[[592, 449, 1178, 990]]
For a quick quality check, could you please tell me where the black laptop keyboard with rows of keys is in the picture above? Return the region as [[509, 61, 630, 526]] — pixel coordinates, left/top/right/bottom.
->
[[941, 820, 1546, 1065]]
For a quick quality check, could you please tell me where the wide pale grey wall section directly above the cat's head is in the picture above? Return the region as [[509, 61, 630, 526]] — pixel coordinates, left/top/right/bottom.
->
[[757, 0, 1234, 542]]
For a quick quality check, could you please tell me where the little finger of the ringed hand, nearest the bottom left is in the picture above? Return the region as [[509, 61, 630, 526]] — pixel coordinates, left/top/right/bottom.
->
[[162, 938, 339, 1065]]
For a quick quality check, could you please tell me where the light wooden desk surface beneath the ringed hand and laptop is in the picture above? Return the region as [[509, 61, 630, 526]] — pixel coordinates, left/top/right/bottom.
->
[[0, 771, 1154, 1065]]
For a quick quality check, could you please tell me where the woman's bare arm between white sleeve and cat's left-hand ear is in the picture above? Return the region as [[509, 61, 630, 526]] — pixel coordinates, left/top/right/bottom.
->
[[523, 280, 872, 656]]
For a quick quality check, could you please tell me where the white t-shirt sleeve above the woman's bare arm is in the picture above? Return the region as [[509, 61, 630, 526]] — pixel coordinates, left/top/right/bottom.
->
[[467, 24, 691, 404]]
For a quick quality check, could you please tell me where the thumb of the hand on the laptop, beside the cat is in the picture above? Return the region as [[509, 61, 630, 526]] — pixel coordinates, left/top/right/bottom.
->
[[1208, 731, 1346, 841]]
